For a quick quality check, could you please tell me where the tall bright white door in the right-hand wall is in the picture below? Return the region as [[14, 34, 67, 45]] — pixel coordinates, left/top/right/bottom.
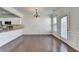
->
[[61, 16, 68, 40]]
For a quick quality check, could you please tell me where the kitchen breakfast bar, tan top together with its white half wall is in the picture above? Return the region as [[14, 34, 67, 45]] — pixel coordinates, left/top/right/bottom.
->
[[0, 25, 23, 47]]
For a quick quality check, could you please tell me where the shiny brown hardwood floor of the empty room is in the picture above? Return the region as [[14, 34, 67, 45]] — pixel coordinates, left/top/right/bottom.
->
[[0, 35, 76, 52]]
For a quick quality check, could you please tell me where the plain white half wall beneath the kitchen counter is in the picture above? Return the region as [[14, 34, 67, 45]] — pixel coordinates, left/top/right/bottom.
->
[[0, 29, 23, 47]]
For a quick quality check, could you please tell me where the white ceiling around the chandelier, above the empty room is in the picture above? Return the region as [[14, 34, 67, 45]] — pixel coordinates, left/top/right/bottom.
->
[[14, 7, 60, 16]]
